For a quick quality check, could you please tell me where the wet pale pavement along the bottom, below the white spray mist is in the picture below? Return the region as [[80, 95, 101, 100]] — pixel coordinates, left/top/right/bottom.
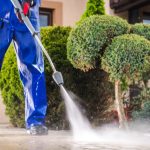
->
[[0, 125, 150, 150]]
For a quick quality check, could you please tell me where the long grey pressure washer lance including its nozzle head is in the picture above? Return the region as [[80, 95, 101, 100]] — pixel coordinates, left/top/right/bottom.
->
[[11, 0, 64, 86]]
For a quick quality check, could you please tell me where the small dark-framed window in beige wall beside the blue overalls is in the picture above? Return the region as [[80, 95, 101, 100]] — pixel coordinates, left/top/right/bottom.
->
[[40, 8, 53, 27]]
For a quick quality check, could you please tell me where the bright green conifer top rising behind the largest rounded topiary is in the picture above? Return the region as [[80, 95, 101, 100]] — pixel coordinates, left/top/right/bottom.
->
[[81, 0, 105, 19]]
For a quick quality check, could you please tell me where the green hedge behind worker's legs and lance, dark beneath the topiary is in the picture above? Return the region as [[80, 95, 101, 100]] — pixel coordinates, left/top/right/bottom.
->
[[0, 27, 113, 129]]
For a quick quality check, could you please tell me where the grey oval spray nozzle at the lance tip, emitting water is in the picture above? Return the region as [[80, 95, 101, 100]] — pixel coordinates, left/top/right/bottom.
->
[[53, 71, 64, 86]]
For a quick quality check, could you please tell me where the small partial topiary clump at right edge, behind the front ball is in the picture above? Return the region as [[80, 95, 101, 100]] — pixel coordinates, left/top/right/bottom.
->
[[130, 23, 150, 40]]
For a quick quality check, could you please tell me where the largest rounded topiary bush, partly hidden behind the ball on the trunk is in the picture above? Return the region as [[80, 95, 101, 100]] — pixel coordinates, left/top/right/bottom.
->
[[67, 15, 129, 71]]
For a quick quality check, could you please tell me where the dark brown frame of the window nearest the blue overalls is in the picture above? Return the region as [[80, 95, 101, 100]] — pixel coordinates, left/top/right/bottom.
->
[[39, 7, 53, 26]]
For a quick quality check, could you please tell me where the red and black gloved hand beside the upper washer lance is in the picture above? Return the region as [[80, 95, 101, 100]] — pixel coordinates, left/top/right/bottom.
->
[[22, 0, 35, 16]]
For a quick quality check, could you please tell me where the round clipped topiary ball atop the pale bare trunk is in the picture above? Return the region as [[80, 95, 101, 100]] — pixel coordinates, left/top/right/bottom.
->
[[102, 34, 150, 83]]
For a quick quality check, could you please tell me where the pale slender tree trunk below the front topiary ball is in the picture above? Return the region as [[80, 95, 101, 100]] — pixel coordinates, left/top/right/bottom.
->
[[115, 80, 128, 129]]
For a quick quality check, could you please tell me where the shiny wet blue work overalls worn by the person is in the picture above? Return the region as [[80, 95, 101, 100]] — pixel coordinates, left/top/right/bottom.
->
[[0, 0, 47, 128]]
